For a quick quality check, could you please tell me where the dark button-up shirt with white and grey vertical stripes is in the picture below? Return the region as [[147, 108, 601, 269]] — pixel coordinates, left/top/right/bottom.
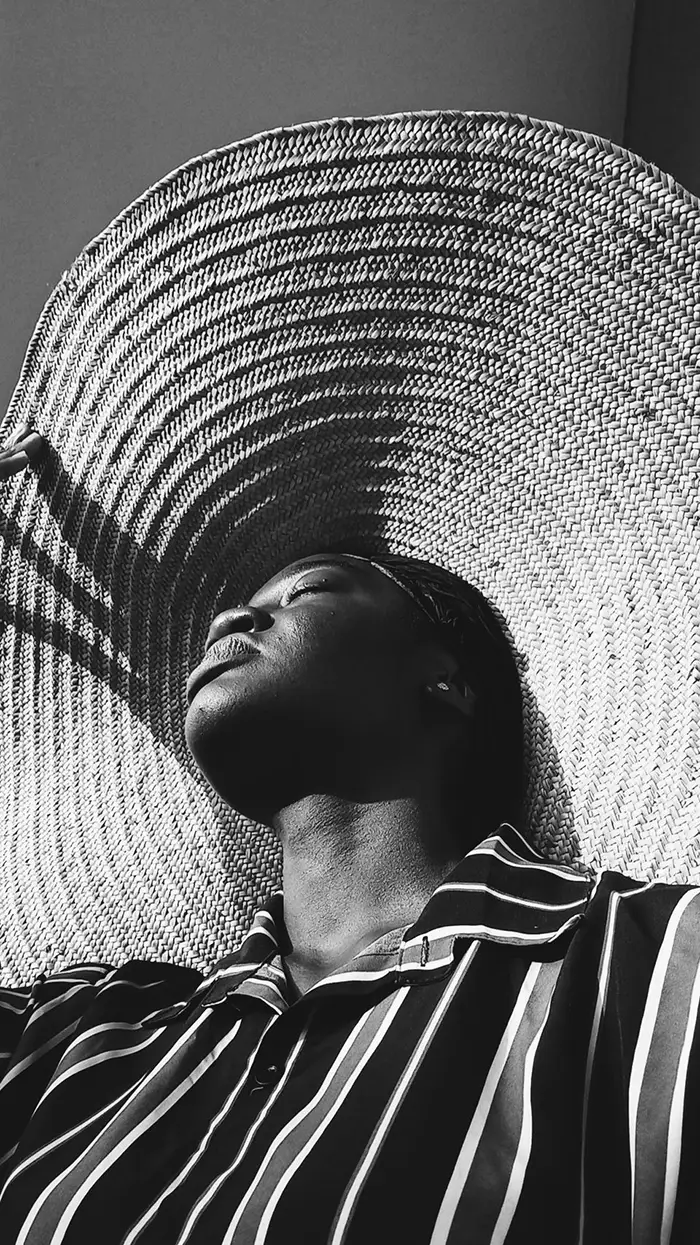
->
[[0, 825, 700, 1245]]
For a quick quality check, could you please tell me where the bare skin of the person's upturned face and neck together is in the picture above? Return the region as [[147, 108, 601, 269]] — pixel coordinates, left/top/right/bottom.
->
[[186, 554, 473, 994]]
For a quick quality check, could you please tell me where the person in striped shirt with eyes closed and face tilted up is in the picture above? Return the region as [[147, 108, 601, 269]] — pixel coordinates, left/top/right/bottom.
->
[[0, 427, 700, 1245]]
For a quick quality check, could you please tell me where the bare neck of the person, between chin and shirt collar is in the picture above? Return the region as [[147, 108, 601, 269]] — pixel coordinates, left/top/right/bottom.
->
[[275, 796, 466, 994]]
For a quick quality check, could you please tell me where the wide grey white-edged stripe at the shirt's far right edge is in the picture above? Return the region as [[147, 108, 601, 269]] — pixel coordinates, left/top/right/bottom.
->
[[629, 890, 700, 1245]]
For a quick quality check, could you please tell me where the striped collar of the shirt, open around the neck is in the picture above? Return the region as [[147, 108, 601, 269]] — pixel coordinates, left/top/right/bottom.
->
[[147, 823, 593, 1025]]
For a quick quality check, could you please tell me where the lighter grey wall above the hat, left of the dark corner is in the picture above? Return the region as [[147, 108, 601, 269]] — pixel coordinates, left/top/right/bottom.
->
[[0, 0, 635, 418]]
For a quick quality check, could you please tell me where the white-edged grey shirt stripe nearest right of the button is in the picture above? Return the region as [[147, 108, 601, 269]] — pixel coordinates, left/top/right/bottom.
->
[[222, 990, 409, 1245]]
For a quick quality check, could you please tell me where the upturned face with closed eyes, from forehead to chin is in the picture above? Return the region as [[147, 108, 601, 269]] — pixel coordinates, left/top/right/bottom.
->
[[186, 554, 445, 824]]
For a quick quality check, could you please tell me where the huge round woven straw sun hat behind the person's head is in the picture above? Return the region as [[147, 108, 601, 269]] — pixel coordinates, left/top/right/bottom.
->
[[0, 112, 700, 982]]
